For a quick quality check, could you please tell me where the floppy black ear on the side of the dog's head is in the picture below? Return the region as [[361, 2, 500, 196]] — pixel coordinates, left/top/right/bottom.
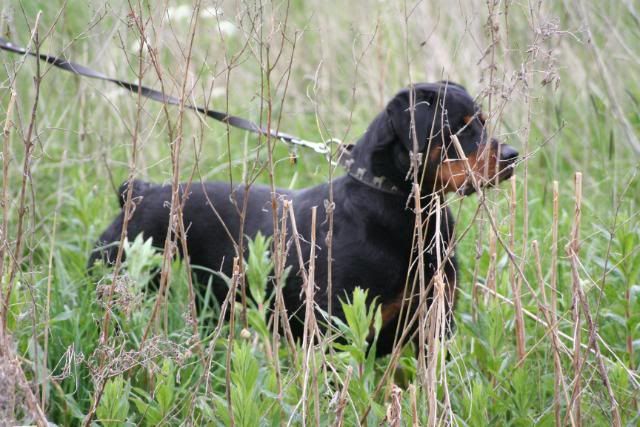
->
[[387, 88, 436, 152]]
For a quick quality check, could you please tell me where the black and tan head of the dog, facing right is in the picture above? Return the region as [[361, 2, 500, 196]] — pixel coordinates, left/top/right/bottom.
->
[[353, 82, 518, 195]]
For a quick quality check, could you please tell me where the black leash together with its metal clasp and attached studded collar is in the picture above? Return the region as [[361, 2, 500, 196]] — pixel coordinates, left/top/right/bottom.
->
[[0, 37, 399, 194]]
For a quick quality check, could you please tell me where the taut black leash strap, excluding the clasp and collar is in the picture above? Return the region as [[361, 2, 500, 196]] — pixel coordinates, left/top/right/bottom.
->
[[0, 37, 330, 154]]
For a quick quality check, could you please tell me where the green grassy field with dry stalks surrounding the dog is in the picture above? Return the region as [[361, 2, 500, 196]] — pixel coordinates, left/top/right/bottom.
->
[[0, 0, 640, 426]]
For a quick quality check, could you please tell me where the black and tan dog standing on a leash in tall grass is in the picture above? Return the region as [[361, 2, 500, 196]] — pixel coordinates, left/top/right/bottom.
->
[[89, 82, 518, 354]]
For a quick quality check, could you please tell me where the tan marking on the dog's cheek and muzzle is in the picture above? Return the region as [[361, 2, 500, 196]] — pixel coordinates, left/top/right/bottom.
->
[[438, 144, 498, 192]]
